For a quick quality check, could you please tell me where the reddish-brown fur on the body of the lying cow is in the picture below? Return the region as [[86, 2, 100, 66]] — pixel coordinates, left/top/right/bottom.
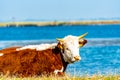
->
[[0, 47, 68, 77]]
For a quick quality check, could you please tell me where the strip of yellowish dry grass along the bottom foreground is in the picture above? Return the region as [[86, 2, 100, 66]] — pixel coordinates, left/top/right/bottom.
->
[[0, 75, 120, 80]]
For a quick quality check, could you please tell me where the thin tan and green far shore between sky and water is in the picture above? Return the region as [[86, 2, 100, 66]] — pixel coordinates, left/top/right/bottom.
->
[[0, 20, 120, 27]]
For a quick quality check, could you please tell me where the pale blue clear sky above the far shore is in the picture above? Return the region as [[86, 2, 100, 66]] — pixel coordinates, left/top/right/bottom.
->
[[0, 0, 120, 21]]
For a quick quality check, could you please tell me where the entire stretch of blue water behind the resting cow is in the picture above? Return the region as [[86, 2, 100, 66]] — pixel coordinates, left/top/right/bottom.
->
[[0, 25, 120, 76]]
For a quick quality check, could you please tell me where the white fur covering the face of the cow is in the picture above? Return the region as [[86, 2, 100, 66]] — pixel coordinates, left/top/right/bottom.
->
[[63, 35, 80, 63]]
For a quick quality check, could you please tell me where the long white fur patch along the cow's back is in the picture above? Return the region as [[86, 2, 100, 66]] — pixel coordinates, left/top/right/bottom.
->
[[16, 43, 57, 51]]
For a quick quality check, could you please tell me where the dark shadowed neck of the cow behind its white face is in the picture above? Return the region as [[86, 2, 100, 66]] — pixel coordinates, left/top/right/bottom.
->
[[53, 46, 68, 72]]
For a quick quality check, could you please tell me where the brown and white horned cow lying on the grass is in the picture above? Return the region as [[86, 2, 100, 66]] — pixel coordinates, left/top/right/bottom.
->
[[0, 33, 87, 77]]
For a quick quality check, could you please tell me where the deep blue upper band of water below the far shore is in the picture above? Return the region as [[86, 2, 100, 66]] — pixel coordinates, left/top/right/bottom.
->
[[0, 25, 120, 40]]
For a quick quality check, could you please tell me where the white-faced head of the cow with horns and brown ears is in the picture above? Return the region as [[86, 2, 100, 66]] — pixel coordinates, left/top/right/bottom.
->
[[57, 33, 87, 63]]
